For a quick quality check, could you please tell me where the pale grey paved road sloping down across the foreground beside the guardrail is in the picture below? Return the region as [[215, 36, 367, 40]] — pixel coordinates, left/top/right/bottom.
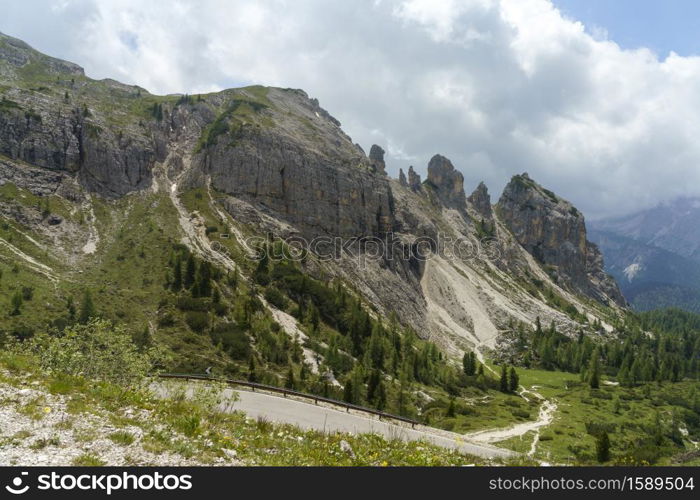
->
[[156, 382, 515, 458]]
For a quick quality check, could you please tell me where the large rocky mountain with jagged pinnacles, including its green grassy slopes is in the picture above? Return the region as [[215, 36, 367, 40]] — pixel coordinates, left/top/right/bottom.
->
[[0, 35, 626, 378]]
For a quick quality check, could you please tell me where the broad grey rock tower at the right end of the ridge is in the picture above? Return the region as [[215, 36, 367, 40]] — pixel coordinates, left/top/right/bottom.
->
[[496, 174, 625, 305]]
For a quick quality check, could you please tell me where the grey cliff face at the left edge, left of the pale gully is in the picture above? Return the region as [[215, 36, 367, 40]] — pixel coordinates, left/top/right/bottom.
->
[[0, 34, 156, 197]]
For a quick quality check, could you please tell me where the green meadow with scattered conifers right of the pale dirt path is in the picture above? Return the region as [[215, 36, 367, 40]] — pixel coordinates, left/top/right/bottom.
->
[[490, 368, 700, 465]]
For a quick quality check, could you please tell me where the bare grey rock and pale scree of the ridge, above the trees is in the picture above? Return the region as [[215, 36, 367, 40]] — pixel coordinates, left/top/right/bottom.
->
[[0, 35, 625, 364]]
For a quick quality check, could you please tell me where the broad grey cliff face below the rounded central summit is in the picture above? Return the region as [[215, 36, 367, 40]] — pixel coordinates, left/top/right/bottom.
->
[[195, 89, 394, 237]]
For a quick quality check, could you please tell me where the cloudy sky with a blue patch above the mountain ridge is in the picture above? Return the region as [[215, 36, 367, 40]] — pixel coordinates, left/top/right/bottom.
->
[[0, 0, 700, 217]]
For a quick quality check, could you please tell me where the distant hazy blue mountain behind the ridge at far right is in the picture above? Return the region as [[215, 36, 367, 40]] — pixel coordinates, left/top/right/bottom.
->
[[590, 198, 700, 312]]
